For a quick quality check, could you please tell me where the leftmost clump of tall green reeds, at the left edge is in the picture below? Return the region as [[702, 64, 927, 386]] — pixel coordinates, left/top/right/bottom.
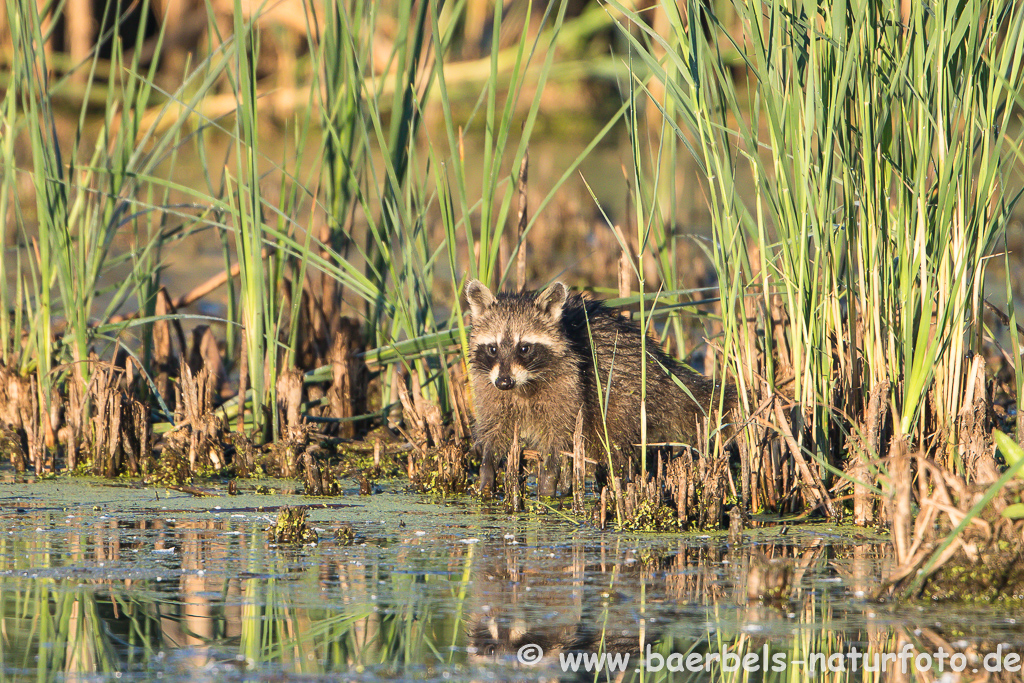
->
[[0, 0, 206, 458]]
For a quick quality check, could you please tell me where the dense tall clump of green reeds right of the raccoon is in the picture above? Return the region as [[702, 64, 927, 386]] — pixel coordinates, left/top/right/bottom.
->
[[611, 0, 1024, 513]]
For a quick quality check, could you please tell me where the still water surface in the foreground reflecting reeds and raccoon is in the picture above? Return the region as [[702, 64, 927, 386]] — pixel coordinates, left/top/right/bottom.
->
[[0, 485, 1024, 681]]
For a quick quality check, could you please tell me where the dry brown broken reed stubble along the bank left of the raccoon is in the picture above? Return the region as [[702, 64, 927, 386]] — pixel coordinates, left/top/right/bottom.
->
[[0, 255, 395, 496]]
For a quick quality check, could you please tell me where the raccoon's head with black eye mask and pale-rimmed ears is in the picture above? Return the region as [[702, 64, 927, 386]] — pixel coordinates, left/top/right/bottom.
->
[[466, 280, 567, 391]]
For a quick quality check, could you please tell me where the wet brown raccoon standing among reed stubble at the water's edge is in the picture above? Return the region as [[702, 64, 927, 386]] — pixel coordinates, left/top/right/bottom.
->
[[466, 280, 735, 496]]
